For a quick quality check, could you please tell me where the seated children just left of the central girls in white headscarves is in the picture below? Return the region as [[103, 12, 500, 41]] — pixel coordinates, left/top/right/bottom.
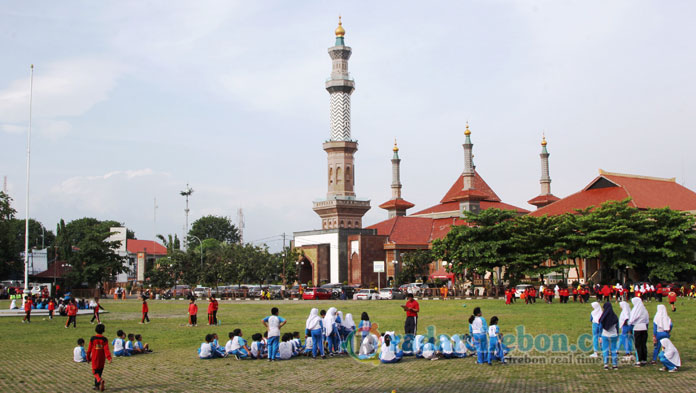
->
[[198, 329, 312, 360]]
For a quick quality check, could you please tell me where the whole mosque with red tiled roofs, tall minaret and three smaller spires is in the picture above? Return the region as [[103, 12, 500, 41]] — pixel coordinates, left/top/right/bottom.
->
[[293, 18, 696, 287]]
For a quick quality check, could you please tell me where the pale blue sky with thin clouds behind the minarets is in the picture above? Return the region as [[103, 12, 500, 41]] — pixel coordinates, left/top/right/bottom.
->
[[0, 0, 696, 249]]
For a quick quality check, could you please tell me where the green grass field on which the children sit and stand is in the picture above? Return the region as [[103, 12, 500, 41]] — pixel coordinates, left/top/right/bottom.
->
[[0, 299, 696, 393]]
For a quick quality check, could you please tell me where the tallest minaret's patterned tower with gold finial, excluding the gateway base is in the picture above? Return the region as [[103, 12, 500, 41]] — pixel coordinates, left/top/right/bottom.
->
[[313, 17, 370, 229]]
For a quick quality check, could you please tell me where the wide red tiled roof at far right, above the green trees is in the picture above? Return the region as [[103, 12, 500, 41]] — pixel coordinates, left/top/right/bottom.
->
[[531, 171, 696, 216]]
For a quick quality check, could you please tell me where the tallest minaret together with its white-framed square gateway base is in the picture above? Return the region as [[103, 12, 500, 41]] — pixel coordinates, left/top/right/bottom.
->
[[293, 18, 374, 284]]
